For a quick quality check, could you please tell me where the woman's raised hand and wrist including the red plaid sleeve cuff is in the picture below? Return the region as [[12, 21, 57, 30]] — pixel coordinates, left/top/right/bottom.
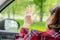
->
[[20, 5, 34, 35]]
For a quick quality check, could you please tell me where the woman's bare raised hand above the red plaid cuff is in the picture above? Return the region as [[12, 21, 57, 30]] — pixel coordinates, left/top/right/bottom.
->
[[23, 5, 35, 28]]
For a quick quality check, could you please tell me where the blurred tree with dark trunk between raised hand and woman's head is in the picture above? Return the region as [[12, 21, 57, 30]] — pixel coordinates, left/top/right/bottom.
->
[[34, 0, 46, 22]]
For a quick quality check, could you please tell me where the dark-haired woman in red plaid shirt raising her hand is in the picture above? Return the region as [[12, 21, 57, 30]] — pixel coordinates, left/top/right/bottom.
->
[[16, 4, 60, 40]]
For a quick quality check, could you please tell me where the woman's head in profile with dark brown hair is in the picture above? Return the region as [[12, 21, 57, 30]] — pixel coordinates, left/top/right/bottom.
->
[[46, 4, 60, 29]]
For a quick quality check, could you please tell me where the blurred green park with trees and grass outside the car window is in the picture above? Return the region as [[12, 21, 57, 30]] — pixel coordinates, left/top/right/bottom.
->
[[0, 0, 60, 31]]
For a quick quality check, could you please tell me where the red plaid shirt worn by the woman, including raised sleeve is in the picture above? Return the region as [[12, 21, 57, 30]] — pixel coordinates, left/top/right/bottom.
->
[[16, 28, 60, 40]]
